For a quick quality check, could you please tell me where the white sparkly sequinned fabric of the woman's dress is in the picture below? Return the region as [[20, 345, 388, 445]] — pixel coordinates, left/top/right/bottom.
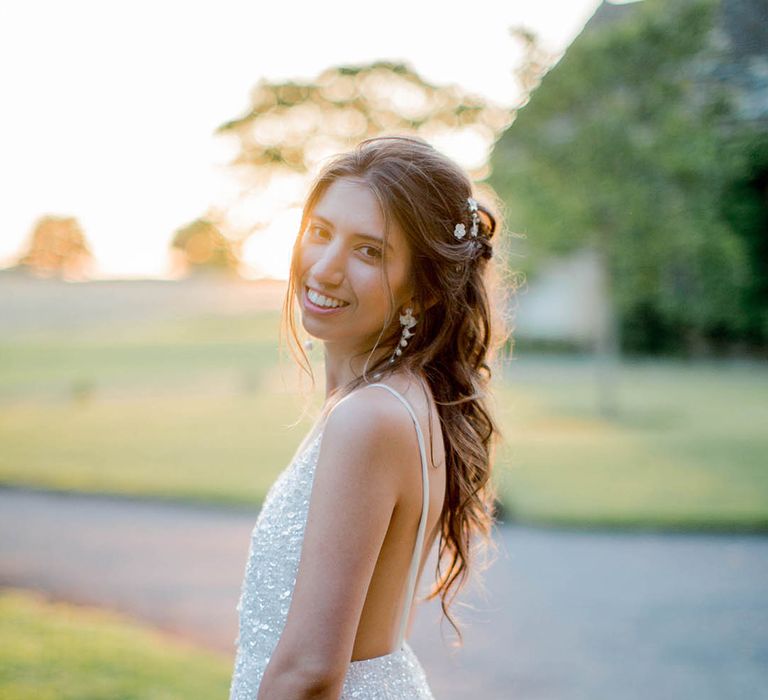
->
[[229, 430, 434, 700]]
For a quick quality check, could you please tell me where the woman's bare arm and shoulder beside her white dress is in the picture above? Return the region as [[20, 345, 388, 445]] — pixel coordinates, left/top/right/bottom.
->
[[258, 392, 412, 700]]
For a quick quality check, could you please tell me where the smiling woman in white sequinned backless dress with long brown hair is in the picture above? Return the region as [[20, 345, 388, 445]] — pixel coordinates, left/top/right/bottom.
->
[[230, 137, 512, 700]]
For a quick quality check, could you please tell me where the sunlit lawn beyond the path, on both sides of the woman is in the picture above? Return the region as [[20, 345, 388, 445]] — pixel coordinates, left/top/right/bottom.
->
[[0, 312, 768, 529]]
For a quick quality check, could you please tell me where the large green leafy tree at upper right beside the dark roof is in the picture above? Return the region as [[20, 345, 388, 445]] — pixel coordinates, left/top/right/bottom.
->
[[491, 0, 748, 352]]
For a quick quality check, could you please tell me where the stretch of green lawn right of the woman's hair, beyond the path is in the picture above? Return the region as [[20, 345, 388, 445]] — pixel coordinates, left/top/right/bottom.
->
[[498, 358, 768, 529]]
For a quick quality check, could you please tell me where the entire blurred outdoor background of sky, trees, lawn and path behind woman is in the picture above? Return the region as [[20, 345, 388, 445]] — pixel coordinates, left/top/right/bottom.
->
[[0, 0, 768, 700]]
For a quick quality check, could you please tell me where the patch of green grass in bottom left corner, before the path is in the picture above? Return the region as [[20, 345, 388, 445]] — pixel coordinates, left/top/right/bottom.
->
[[0, 589, 233, 700]]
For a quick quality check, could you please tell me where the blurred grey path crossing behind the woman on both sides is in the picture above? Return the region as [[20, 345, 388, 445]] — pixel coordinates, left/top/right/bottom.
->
[[0, 489, 768, 700]]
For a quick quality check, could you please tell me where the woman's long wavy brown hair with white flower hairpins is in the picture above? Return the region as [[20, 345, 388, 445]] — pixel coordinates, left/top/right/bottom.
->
[[281, 136, 514, 645]]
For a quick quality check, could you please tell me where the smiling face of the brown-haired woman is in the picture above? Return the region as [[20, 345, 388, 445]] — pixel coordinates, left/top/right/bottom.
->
[[297, 178, 412, 350]]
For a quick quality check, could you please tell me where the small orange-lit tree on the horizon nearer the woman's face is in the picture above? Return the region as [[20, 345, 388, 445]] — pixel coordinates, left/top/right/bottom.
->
[[171, 217, 240, 275]]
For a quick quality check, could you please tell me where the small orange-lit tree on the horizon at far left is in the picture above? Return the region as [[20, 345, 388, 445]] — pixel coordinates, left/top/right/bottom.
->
[[17, 214, 93, 280]]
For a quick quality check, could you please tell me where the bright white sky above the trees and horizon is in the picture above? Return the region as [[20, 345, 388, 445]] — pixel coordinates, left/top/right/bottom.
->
[[0, 0, 612, 278]]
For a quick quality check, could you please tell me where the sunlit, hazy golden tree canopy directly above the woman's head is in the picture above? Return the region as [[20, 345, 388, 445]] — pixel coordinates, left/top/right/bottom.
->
[[217, 61, 510, 182]]
